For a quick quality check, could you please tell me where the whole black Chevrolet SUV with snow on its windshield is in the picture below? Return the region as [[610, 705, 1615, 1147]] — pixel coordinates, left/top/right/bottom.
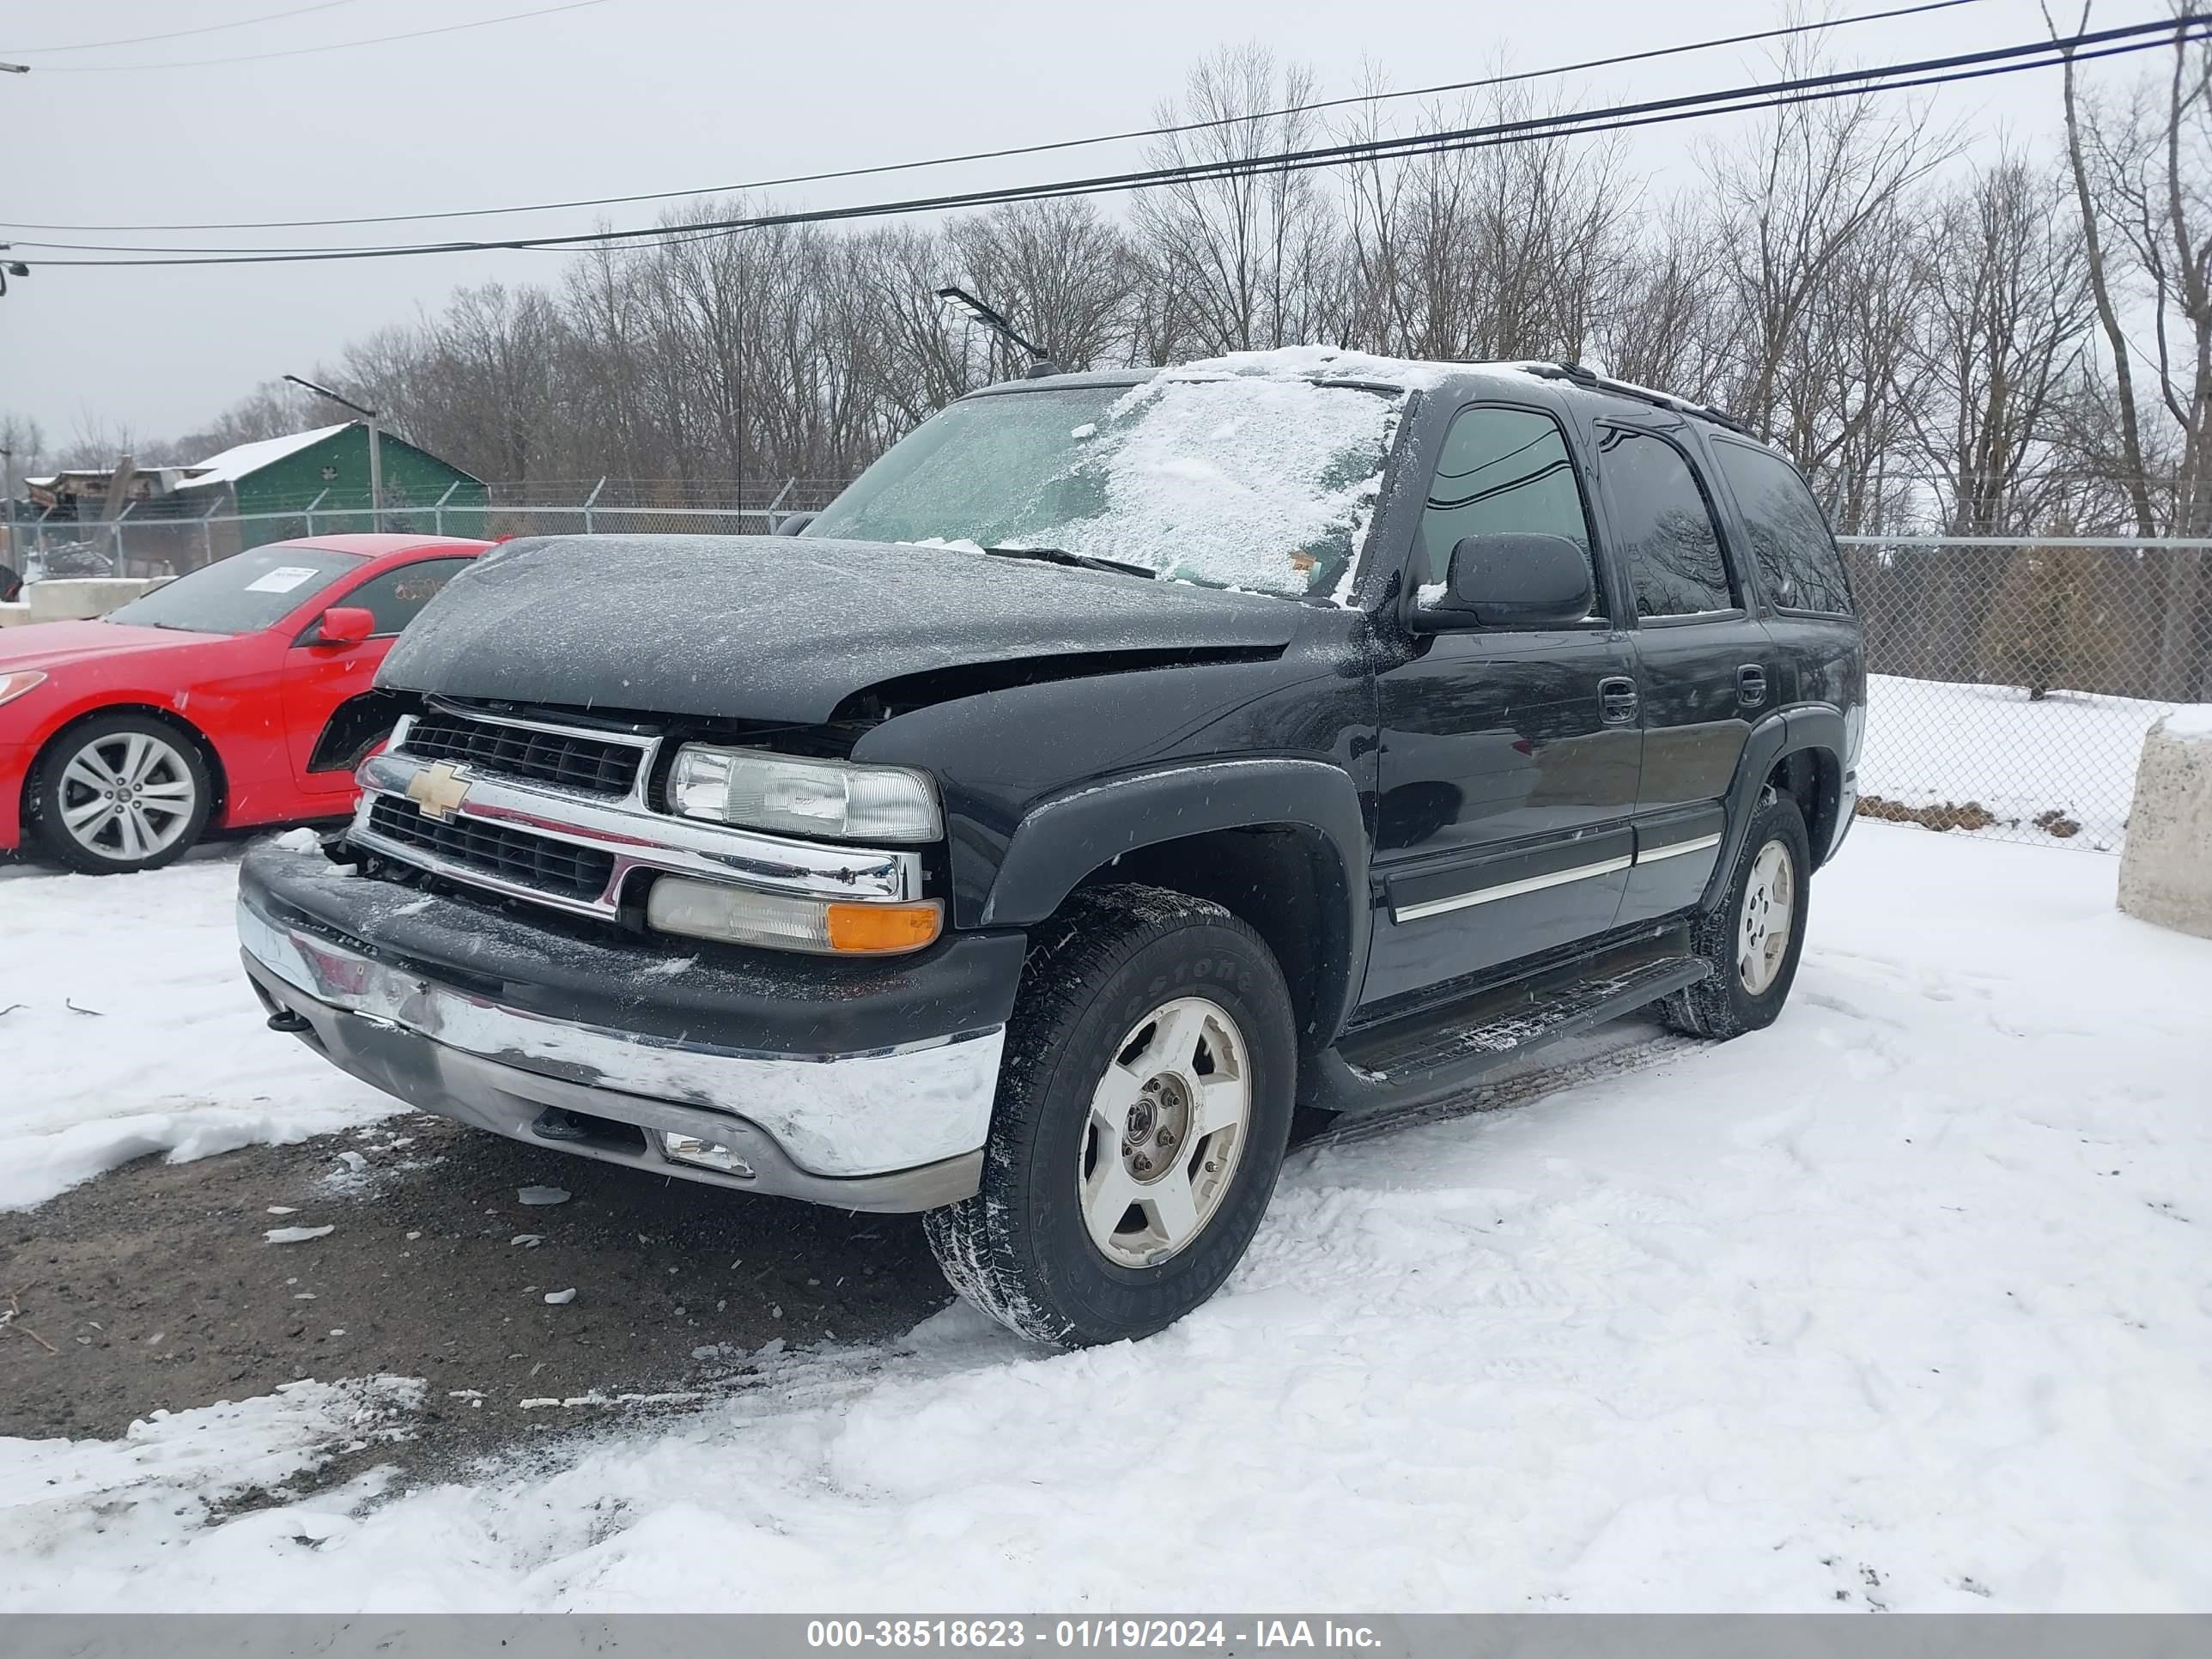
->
[[239, 347, 1865, 1345]]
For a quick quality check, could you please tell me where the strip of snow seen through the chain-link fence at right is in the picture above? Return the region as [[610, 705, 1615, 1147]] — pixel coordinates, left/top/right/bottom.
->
[[1858, 675, 2212, 848]]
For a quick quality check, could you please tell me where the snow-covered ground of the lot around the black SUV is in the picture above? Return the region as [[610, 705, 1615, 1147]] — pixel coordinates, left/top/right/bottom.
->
[[0, 823, 2212, 1610]]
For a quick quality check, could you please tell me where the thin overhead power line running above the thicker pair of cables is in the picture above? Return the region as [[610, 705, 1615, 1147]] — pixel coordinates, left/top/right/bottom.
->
[[0, 0, 1982, 234]]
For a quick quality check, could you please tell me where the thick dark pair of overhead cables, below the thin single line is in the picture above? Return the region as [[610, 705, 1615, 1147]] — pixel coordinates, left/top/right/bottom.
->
[[18, 13, 2212, 268]]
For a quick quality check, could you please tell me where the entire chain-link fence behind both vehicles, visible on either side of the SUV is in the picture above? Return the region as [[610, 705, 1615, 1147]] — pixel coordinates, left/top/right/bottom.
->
[[0, 500, 2212, 849]]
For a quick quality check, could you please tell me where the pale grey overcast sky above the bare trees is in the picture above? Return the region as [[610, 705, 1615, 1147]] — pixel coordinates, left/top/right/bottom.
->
[[0, 0, 2163, 445]]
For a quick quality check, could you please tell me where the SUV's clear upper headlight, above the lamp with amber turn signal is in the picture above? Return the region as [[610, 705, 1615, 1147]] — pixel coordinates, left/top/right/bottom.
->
[[668, 744, 942, 841]]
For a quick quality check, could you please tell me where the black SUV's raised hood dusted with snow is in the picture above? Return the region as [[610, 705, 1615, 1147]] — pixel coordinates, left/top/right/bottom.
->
[[376, 535, 1298, 723]]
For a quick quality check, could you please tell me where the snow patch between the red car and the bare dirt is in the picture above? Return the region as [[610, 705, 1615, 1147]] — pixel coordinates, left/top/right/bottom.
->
[[0, 854, 403, 1210]]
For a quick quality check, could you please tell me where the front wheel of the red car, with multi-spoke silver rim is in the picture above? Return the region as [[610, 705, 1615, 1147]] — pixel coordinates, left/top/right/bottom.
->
[[28, 712, 215, 876]]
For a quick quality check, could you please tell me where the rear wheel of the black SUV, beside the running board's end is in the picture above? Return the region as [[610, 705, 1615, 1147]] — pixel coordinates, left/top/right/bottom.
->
[[1662, 796, 1812, 1037]]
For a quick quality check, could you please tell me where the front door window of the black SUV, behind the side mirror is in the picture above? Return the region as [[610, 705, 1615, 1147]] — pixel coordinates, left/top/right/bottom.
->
[[1420, 407, 1604, 615]]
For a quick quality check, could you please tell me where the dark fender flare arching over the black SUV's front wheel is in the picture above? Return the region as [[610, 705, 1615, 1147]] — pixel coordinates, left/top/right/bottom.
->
[[980, 759, 1374, 1040]]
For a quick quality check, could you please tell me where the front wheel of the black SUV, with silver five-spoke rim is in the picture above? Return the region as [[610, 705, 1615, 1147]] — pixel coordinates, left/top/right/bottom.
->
[[922, 887, 1298, 1347]]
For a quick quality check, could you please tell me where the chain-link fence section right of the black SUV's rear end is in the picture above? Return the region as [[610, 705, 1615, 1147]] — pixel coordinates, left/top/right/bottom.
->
[[1838, 535, 2212, 849]]
